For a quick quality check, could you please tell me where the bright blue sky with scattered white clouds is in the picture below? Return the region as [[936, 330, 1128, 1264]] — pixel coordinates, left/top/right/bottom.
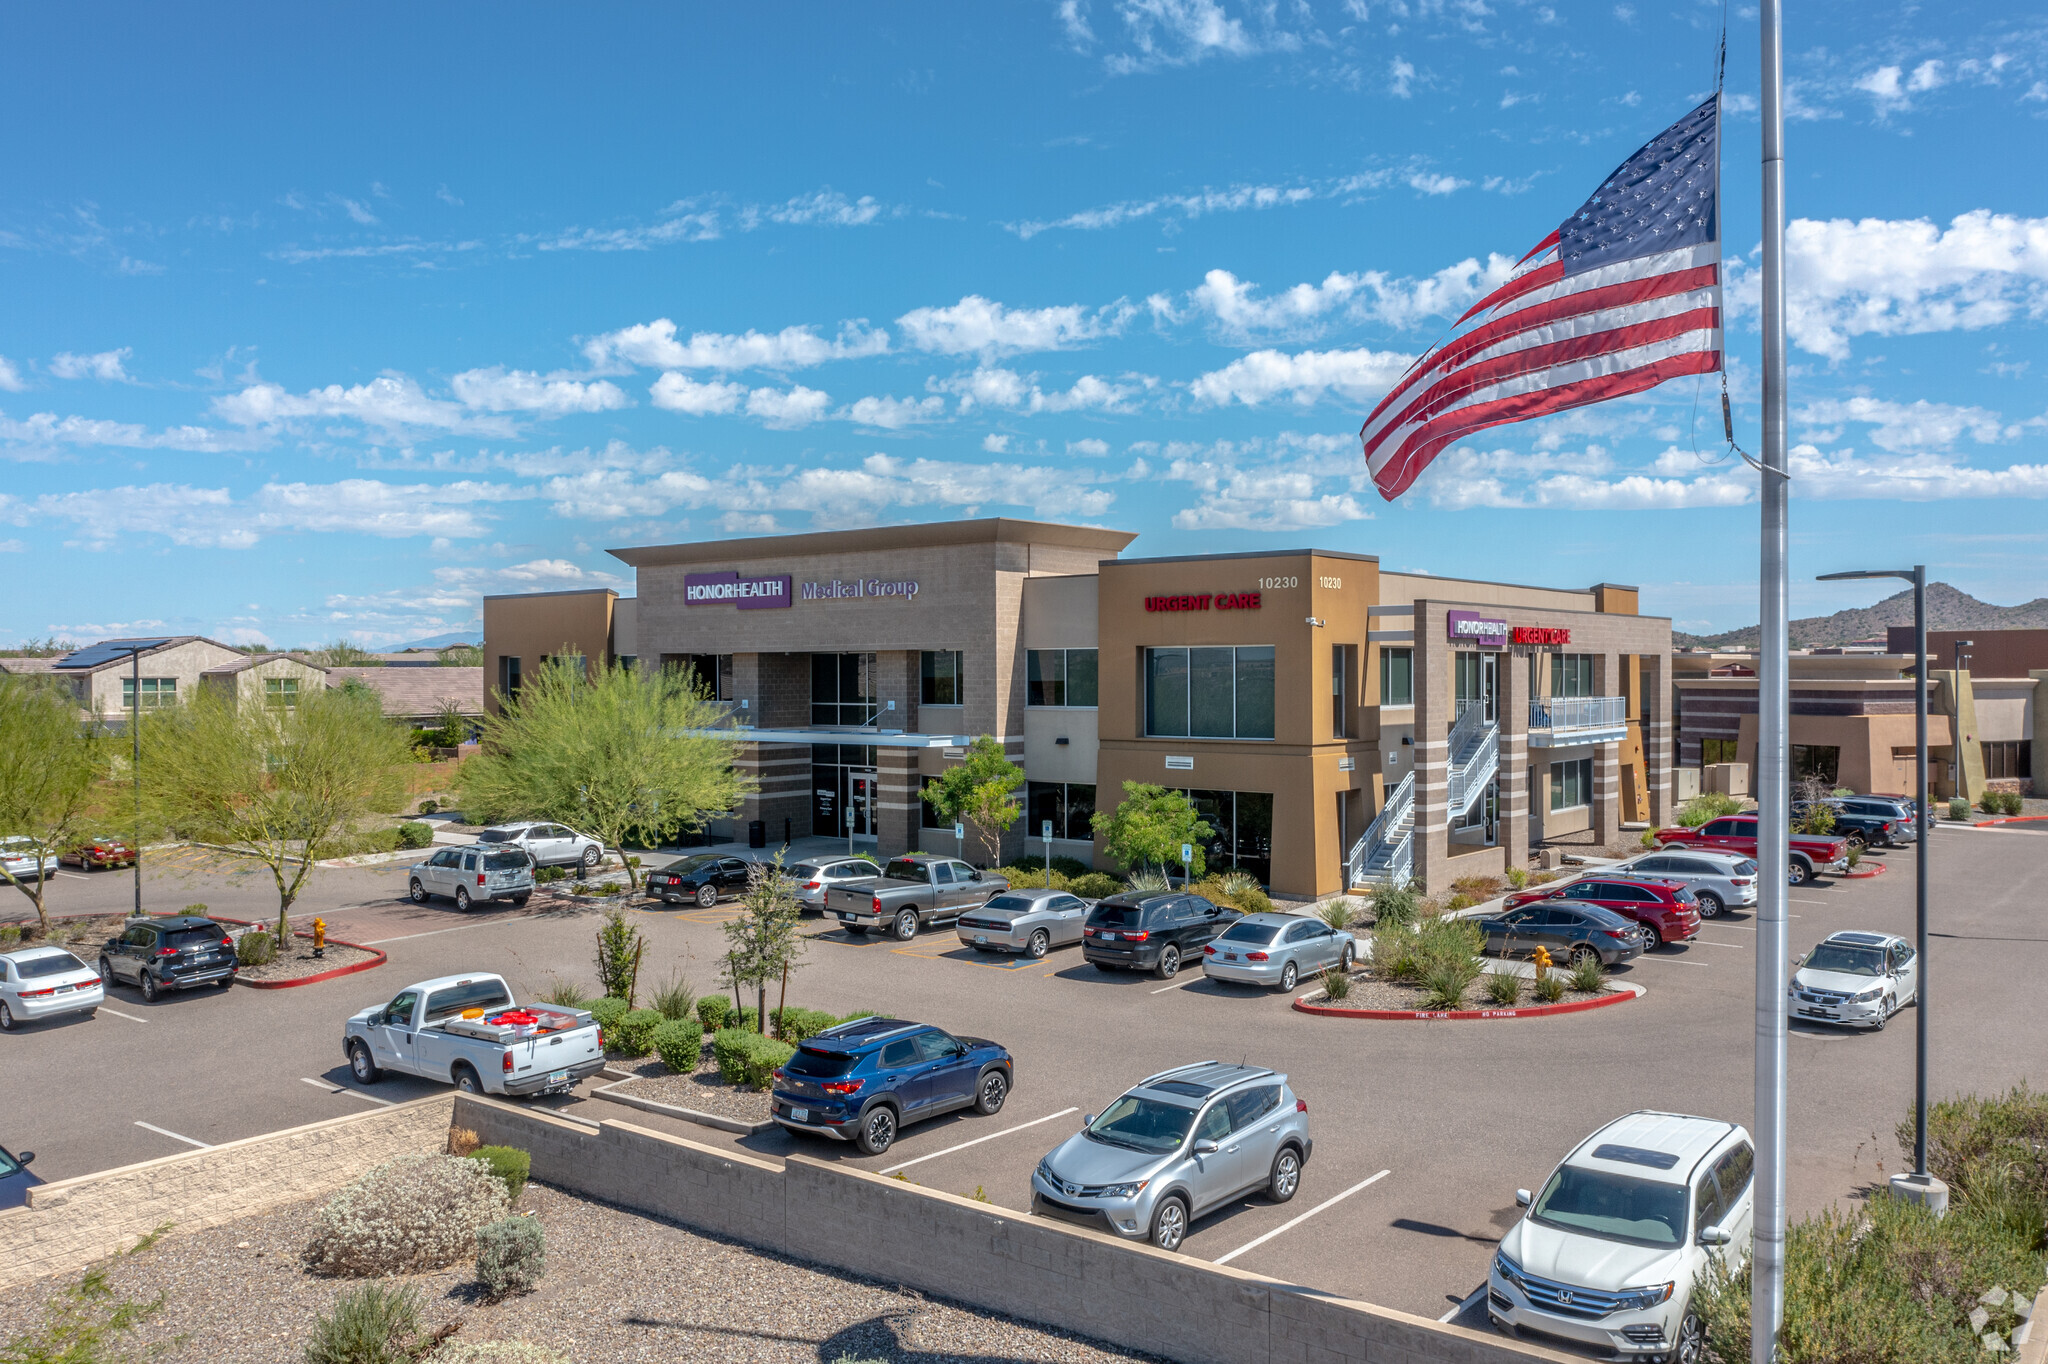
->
[[0, 0, 2048, 645]]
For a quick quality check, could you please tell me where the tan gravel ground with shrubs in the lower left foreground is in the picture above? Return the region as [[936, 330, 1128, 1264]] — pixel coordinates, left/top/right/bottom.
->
[[0, 1184, 1153, 1364]]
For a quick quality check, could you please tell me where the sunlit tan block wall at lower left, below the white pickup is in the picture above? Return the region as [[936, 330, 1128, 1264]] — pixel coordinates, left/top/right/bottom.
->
[[0, 1094, 455, 1288]]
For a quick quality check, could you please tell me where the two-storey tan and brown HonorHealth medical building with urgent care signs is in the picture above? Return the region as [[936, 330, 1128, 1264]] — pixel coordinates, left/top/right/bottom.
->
[[483, 518, 1671, 897]]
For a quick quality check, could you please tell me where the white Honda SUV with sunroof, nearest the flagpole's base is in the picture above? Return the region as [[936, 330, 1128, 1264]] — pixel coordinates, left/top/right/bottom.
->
[[1487, 1112, 1757, 1364]]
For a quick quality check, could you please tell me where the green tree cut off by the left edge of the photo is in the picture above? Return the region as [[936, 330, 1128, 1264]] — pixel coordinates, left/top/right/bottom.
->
[[0, 676, 113, 936]]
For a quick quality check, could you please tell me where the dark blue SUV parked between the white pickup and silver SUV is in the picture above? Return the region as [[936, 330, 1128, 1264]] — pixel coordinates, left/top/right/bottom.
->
[[774, 1018, 1016, 1155]]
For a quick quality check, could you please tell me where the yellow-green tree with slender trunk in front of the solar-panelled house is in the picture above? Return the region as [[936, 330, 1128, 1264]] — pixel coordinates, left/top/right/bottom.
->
[[141, 675, 412, 946]]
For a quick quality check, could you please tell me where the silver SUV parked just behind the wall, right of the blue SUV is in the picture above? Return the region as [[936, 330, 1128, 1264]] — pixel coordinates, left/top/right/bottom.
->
[[1030, 1061, 1315, 1251]]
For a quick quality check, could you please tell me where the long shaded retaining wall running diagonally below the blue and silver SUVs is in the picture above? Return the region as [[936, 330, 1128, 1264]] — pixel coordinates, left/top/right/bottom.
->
[[455, 1094, 1577, 1364]]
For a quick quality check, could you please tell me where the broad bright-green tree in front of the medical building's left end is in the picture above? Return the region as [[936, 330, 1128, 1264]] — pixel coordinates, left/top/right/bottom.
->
[[457, 649, 754, 887]]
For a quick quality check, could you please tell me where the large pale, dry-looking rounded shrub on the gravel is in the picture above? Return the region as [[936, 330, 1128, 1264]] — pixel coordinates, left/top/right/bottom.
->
[[305, 1155, 508, 1276]]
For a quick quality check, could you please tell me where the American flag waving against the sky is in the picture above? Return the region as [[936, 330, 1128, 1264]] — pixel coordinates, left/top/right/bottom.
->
[[1358, 96, 1720, 502]]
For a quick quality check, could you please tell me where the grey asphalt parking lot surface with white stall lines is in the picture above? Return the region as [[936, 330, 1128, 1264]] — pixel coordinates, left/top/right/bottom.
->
[[0, 829, 2048, 1317]]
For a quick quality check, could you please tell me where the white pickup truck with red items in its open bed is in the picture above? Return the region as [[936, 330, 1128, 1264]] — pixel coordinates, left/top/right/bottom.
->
[[342, 973, 604, 1096]]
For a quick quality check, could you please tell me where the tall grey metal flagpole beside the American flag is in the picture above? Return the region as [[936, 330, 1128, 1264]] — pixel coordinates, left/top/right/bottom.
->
[[1749, 0, 1792, 1364]]
